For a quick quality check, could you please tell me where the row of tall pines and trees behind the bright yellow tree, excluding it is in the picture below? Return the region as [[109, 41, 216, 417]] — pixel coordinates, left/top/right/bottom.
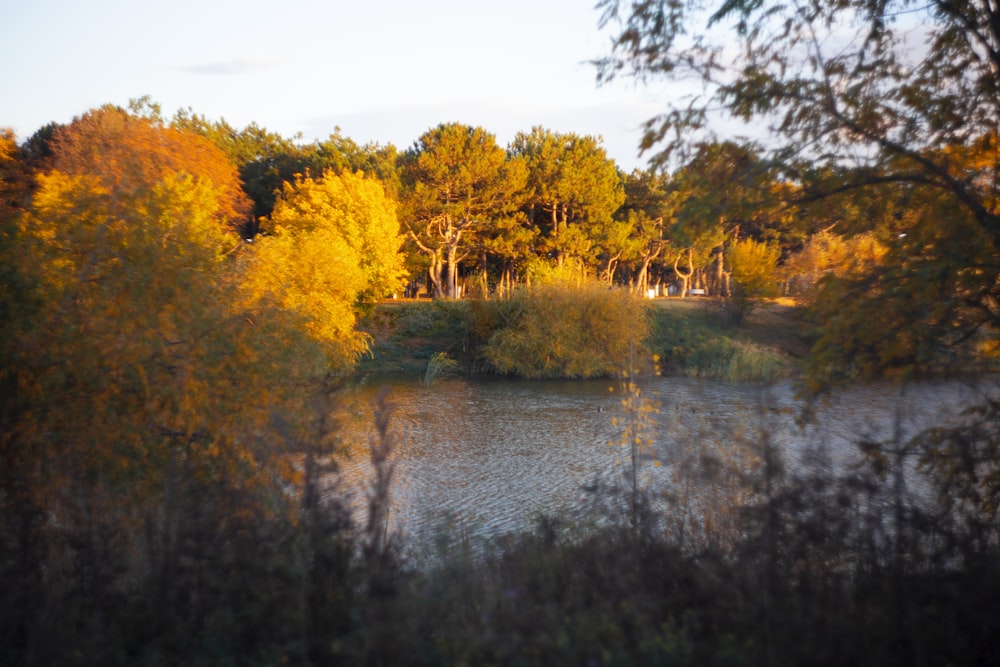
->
[[9, 100, 936, 308]]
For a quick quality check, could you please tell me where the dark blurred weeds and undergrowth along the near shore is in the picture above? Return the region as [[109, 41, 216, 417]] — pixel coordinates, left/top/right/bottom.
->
[[0, 388, 1000, 666]]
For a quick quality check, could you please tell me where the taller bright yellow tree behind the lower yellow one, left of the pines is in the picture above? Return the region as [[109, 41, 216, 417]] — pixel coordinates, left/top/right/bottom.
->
[[270, 170, 404, 302]]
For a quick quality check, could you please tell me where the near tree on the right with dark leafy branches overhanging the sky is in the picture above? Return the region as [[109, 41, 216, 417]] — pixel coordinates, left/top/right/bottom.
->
[[598, 0, 1000, 384]]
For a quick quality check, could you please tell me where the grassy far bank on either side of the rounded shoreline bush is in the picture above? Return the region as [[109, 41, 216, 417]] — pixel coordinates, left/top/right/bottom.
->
[[358, 298, 811, 382]]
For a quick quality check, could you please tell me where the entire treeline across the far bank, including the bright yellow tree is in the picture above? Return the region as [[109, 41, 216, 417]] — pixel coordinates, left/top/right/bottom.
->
[[5, 99, 998, 389]]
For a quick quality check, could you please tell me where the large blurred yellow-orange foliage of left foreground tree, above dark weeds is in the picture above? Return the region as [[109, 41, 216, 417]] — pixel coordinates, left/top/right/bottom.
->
[[24, 166, 323, 496]]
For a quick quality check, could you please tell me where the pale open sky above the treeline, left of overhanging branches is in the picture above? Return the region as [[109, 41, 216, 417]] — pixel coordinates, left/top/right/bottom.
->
[[0, 0, 665, 171]]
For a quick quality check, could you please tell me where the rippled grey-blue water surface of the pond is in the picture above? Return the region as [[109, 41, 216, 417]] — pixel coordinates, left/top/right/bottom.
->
[[328, 378, 983, 552]]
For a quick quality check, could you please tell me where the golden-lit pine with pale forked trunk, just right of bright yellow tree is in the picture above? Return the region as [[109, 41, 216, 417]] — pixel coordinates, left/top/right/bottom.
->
[[402, 123, 526, 299]]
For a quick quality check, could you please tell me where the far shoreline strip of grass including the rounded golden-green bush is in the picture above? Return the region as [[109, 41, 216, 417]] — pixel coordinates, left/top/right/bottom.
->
[[359, 294, 801, 383]]
